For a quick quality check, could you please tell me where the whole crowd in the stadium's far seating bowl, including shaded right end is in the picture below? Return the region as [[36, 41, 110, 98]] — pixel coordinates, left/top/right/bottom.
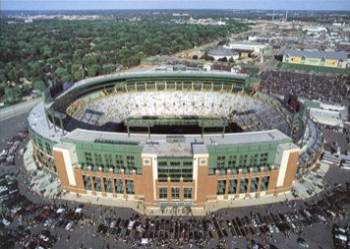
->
[[69, 91, 291, 134]]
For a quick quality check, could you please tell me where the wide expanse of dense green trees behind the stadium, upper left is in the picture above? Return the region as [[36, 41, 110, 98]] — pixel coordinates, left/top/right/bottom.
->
[[0, 15, 248, 104]]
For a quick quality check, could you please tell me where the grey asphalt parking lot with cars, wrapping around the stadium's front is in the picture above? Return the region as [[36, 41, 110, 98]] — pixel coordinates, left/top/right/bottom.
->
[[0, 113, 350, 249]]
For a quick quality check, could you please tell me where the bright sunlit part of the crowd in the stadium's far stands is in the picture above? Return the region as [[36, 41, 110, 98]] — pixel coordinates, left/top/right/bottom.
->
[[74, 91, 264, 123]]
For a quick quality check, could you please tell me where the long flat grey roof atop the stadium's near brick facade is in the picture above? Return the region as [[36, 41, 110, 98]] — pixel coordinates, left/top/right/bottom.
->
[[64, 129, 290, 156]]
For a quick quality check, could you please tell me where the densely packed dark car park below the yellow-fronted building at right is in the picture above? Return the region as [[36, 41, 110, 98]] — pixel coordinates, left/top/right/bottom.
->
[[261, 71, 350, 104]]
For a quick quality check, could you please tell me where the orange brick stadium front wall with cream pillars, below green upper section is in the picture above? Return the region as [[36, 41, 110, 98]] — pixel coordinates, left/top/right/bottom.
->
[[47, 131, 299, 211]]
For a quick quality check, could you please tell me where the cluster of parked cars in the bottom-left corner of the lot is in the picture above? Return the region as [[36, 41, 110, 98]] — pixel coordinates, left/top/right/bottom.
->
[[0, 195, 83, 249]]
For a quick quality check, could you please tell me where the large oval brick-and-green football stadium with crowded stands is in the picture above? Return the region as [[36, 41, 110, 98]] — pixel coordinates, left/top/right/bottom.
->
[[28, 72, 321, 214]]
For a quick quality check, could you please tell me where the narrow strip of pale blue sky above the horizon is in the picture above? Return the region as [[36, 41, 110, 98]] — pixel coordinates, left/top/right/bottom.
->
[[0, 0, 350, 10]]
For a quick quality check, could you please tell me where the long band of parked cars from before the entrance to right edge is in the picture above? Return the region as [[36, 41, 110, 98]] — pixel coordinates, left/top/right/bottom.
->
[[93, 184, 350, 248]]
